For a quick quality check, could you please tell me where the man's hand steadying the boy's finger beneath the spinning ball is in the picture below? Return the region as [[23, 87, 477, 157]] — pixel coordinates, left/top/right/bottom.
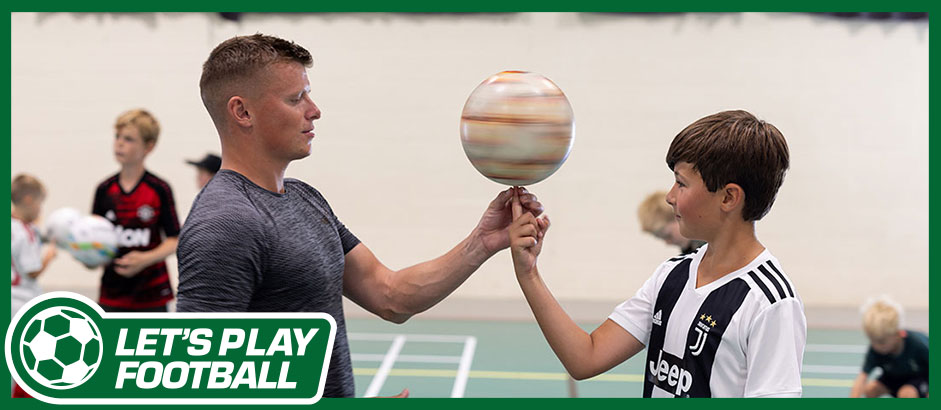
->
[[475, 187, 543, 257]]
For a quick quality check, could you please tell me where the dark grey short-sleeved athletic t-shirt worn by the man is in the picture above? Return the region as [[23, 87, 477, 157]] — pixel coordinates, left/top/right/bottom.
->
[[177, 170, 359, 397]]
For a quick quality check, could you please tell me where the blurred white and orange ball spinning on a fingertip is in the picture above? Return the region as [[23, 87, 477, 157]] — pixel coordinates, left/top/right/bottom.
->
[[461, 71, 575, 186]]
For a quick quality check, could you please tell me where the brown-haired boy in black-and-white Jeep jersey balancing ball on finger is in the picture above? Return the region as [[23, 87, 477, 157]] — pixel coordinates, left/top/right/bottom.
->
[[510, 111, 807, 397]]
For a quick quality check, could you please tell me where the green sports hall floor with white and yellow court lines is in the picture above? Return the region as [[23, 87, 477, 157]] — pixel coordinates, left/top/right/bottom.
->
[[347, 318, 866, 397]]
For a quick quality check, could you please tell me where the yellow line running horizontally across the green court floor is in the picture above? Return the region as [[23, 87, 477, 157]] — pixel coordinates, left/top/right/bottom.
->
[[353, 368, 853, 387]]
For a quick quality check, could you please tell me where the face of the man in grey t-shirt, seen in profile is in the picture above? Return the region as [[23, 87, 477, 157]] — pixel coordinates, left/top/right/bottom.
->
[[246, 62, 320, 161]]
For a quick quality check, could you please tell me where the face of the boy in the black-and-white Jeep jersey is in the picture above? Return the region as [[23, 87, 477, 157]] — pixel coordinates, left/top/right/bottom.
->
[[667, 162, 722, 241]]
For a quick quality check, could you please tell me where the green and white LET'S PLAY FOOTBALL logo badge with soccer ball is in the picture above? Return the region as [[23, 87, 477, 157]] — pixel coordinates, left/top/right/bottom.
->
[[6, 292, 336, 404]]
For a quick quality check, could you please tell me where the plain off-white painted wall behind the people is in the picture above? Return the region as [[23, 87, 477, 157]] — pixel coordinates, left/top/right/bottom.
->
[[11, 13, 928, 314]]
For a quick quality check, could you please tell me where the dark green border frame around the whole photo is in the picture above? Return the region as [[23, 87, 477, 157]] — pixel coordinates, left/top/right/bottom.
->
[[0, 4, 941, 410]]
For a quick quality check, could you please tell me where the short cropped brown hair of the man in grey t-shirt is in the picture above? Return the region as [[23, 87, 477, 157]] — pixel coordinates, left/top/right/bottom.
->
[[199, 33, 314, 125]]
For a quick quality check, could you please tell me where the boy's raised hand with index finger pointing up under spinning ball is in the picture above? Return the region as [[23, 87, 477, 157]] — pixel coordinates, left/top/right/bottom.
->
[[509, 188, 549, 275]]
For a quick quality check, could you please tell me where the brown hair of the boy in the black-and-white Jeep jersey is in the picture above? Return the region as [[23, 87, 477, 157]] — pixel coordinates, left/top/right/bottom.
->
[[667, 110, 790, 221]]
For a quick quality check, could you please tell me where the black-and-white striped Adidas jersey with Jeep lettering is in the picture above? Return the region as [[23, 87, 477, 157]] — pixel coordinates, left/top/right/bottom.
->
[[609, 245, 807, 397]]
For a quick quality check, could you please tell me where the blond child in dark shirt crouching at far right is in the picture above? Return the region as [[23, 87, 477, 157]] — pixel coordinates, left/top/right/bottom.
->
[[850, 297, 928, 398]]
